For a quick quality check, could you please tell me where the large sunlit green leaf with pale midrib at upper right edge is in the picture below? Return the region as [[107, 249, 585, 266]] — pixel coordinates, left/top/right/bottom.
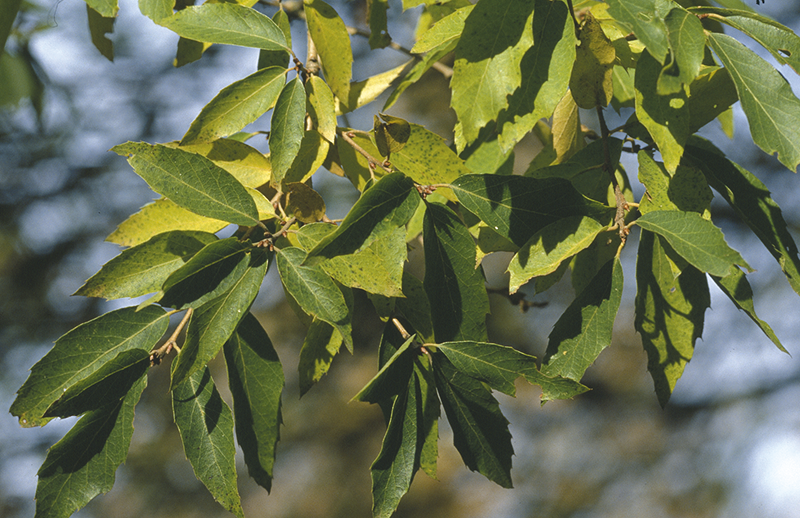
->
[[707, 33, 800, 171]]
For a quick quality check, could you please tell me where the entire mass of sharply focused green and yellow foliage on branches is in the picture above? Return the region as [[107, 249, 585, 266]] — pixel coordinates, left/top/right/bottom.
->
[[6, 0, 800, 517]]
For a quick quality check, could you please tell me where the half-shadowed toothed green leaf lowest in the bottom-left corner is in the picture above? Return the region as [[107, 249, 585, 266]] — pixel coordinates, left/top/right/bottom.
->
[[35, 376, 147, 518]]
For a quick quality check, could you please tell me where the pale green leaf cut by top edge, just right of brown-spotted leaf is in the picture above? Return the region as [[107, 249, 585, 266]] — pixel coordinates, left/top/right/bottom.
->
[[608, 0, 675, 64]]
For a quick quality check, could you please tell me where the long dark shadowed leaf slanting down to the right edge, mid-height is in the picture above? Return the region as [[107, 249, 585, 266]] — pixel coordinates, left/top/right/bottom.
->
[[686, 143, 800, 294]]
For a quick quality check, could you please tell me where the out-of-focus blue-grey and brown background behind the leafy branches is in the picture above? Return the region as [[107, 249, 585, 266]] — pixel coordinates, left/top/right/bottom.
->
[[0, 0, 800, 518]]
